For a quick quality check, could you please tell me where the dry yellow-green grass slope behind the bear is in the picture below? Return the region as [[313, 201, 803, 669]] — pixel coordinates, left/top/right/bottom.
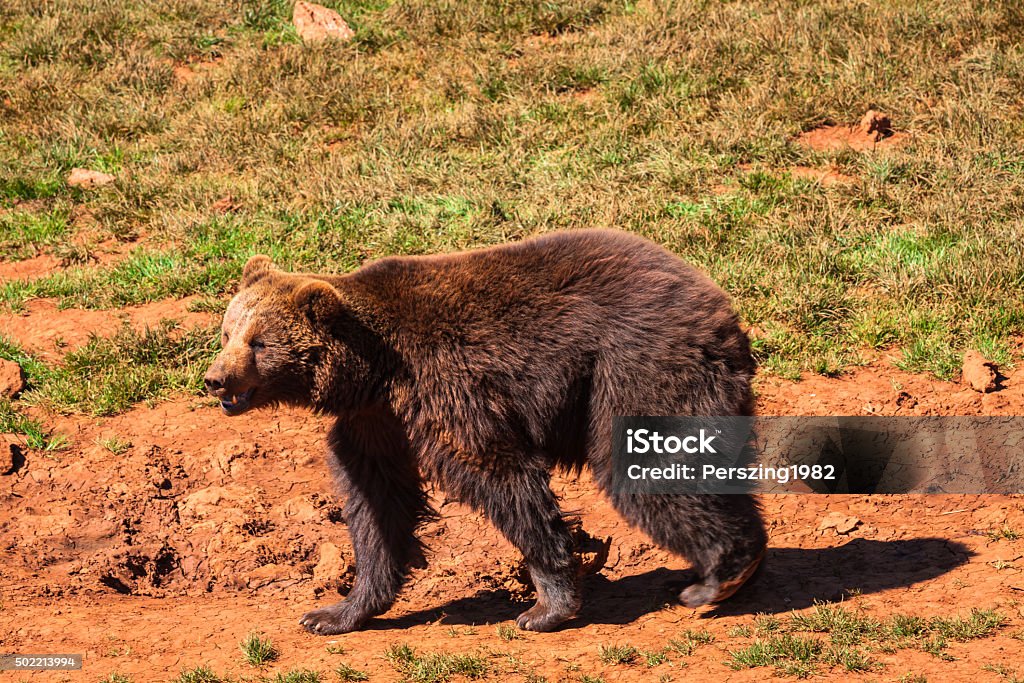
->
[[0, 0, 1024, 385]]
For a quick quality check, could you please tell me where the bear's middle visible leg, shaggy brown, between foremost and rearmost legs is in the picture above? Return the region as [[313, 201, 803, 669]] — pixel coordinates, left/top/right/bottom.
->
[[445, 468, 582, 631]]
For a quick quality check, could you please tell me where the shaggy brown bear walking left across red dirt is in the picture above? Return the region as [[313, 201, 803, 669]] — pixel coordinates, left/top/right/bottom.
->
[[206, 230, 766, 634]]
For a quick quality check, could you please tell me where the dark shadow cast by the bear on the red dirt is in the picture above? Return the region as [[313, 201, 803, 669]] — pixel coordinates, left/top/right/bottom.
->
[[366, 539, 974, 630]]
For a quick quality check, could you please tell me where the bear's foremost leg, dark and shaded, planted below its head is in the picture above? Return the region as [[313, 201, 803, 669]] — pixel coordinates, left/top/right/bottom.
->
[[300, 420, 431, 635]]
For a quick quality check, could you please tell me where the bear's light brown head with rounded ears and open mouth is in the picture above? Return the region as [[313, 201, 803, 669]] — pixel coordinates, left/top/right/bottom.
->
[[205, 256, 343, 415]]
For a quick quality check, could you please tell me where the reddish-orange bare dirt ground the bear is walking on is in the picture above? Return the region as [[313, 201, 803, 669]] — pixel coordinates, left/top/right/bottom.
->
[[0, 302, 1024, 682]]
